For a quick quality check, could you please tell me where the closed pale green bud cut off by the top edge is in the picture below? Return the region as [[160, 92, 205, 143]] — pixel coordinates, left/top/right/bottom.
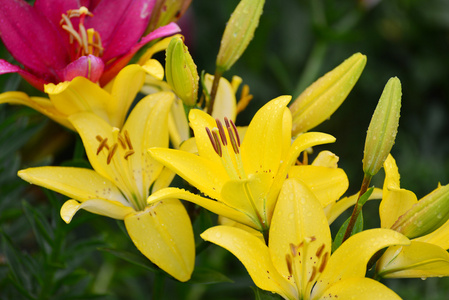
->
[[217, 0, 265, 74]]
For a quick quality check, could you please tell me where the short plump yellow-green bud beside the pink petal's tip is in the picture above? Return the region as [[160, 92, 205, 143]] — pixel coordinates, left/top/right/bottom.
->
[[165, 37, 199, 106]]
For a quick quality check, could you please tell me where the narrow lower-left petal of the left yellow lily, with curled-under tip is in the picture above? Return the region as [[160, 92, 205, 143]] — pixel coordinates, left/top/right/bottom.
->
[[60, 199, 135, 224]]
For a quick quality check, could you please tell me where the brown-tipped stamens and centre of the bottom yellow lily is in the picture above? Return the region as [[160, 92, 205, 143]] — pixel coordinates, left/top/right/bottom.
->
[[285, 236, 329, 299]]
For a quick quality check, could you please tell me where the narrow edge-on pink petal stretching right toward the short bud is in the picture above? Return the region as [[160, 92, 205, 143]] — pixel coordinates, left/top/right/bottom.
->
[[100, 23, 181, 86]]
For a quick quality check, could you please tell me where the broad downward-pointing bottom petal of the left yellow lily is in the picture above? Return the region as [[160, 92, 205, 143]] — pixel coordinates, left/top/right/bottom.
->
[[125, 199, 195, 282]]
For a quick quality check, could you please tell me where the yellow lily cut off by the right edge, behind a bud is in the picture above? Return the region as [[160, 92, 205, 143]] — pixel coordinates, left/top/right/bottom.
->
[[376, 155, 449, 278]]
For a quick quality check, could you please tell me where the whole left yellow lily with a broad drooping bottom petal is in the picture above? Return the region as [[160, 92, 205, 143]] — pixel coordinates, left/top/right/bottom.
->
[[18, 92, 195, 281]]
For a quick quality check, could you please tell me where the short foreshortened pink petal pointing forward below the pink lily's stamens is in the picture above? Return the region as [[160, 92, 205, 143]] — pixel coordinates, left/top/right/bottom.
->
[[62, 54, 104, 82]]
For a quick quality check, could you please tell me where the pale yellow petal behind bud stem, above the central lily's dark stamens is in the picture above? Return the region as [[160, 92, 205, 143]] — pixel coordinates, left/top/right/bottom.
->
[[204, 74, 237, 121]]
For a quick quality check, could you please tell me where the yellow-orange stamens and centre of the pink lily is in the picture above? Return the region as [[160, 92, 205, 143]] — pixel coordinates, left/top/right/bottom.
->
[[59, 6, 104, 60]]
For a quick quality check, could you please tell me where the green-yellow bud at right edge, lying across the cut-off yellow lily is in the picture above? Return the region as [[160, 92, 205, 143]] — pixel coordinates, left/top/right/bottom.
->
[[391, 185, 449, 238]]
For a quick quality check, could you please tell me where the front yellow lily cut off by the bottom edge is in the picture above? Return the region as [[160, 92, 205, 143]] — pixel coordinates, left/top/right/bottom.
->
[[201, 179, 410, 300]]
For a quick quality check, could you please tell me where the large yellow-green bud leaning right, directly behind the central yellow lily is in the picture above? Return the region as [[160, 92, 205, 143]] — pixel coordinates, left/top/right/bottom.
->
[[290, 53, 366, 136]]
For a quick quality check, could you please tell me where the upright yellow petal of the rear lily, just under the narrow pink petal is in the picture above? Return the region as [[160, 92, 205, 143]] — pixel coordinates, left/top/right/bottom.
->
[[106, 65, 145, 128]]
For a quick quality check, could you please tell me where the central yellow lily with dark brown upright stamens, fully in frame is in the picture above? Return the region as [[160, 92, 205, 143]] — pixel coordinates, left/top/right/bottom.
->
[[148, 96, 335, 232]]
